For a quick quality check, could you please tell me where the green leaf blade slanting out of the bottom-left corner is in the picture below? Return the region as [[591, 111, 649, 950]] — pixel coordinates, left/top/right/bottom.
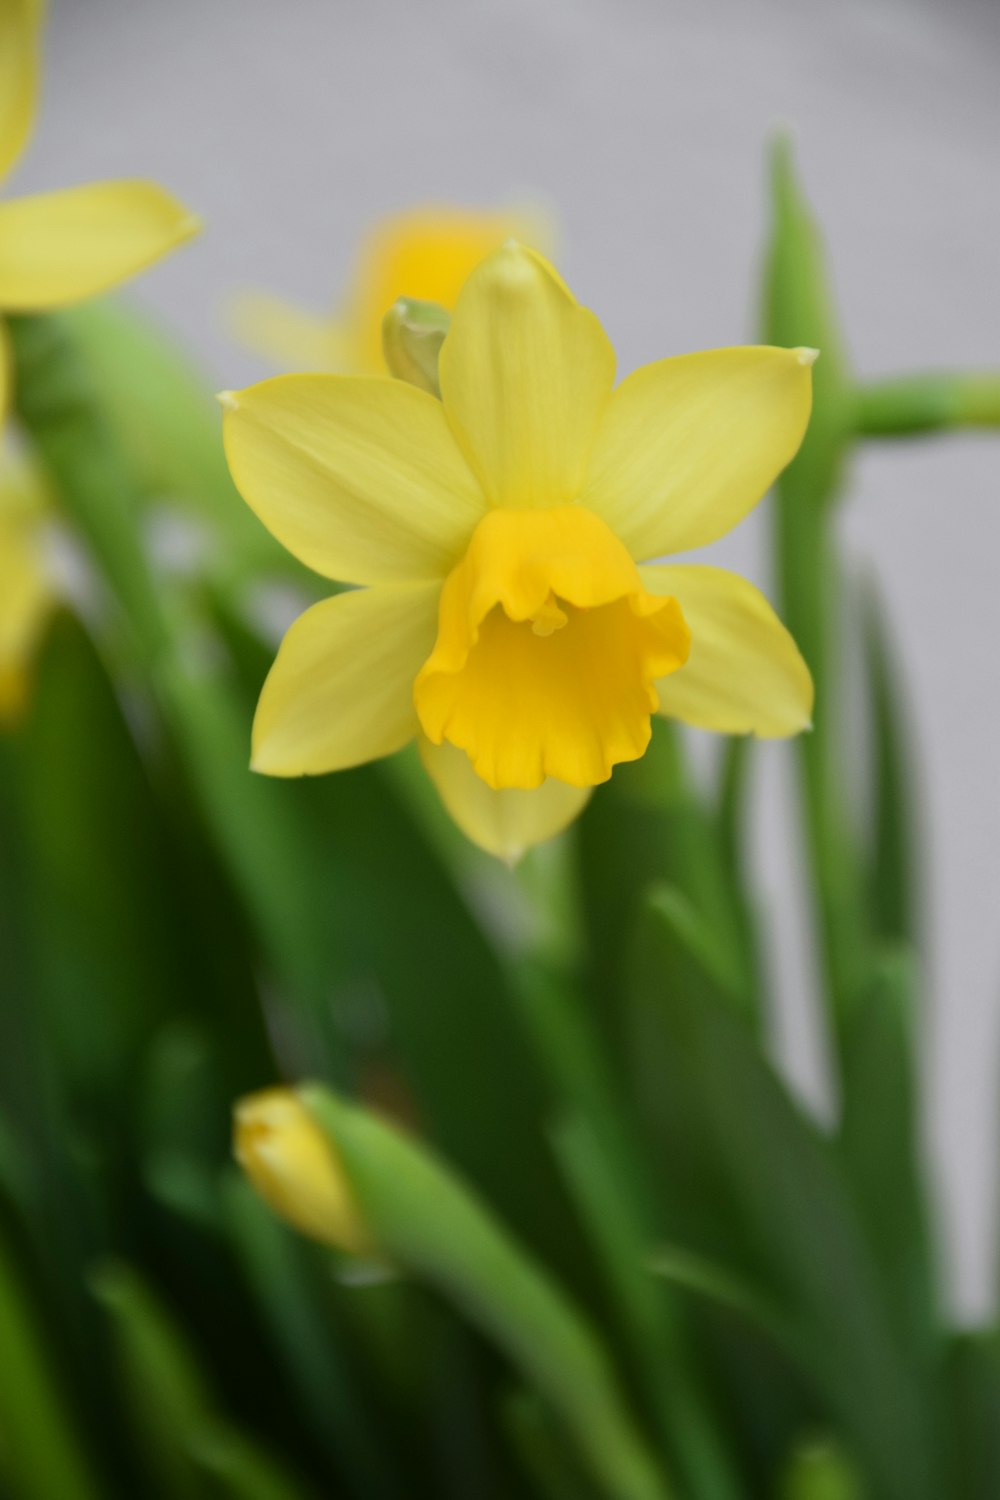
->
[[0, 1218, 106, 1500]]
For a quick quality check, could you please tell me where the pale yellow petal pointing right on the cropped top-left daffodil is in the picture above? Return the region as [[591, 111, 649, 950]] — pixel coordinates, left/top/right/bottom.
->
[[0, 182, 198, 312]]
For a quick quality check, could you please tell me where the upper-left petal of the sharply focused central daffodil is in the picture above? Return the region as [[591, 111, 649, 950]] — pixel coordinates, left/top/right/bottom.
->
[[222, 375, 486, 584]]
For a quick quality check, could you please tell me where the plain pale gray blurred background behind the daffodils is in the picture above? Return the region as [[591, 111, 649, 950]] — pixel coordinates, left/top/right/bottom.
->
[[21, 0, 1000, 1316]]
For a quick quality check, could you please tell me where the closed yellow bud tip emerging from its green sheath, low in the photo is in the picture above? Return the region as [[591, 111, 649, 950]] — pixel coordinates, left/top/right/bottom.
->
[[234, 1089, 376, 1256]]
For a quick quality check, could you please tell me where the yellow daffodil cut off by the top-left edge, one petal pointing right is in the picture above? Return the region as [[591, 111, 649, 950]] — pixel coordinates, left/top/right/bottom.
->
[[0, 0, 198, 423]]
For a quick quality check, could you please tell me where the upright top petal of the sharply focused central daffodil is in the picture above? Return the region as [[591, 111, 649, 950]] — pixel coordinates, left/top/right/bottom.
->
[[441, 242, 615, 507]]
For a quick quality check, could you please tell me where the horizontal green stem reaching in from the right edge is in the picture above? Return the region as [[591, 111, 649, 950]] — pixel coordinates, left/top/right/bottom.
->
[[855, 372, 1000, 438]]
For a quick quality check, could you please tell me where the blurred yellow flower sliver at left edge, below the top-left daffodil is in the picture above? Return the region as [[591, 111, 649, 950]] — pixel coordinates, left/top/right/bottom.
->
[[0, 452, 52, 728]]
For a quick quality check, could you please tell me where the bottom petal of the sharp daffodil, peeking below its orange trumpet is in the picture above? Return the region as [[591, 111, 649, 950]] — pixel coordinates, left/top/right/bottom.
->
[[418, 737, 591, 864]]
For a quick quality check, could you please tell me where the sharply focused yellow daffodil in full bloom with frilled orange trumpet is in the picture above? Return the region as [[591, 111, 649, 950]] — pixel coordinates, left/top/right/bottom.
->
[[223, 243, 814, 858]]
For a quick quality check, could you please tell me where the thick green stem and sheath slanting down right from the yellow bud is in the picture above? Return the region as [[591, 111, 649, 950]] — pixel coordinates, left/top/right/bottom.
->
[[301, 1088, 672, 1500]]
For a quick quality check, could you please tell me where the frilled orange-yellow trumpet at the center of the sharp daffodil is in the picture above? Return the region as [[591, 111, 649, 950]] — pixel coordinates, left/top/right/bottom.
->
[[414, 506, 691, 791]]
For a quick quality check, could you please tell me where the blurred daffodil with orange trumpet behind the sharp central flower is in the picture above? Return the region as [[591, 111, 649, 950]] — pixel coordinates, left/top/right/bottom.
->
[[232, 207, 544, 375]]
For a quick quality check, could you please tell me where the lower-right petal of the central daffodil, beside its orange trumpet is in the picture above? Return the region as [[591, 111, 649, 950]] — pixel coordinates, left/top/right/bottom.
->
[[639, 564, 813, 740]]
